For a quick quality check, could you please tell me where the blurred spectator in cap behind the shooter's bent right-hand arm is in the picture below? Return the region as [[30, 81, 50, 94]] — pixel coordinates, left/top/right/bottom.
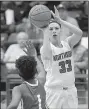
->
[[57, 4, 79, 40]]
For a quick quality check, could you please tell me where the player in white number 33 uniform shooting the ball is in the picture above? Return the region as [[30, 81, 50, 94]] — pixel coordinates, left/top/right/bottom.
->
[[40, 7, 82, 109]]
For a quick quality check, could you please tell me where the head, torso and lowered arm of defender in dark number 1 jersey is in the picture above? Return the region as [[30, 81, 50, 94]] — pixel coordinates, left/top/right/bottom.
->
[[7, 56, 46, 109]]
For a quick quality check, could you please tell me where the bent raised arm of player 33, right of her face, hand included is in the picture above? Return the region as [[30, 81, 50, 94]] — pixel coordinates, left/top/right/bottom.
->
[[52, 6, 83, 47]]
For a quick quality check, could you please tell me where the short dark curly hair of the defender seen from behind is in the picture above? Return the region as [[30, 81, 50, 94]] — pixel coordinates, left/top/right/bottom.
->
[[15, 56, 37, 80]]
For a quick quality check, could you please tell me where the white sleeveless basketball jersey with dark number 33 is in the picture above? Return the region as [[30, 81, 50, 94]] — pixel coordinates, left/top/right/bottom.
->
[[41, 41, 75, 89]]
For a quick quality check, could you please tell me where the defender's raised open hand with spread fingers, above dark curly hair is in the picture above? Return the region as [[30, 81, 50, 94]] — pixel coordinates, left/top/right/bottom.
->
[[23, 40, 37, 57]]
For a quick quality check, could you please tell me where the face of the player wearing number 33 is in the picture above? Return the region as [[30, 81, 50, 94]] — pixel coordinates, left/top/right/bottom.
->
[[49, 22, 61, 41]]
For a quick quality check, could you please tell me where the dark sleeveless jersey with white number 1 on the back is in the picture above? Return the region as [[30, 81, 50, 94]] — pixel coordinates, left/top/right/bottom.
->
[[19, 81, 46, 109]]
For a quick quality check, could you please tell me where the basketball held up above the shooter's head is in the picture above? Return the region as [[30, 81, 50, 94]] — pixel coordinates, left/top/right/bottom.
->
[[29, 5, 51, 28]]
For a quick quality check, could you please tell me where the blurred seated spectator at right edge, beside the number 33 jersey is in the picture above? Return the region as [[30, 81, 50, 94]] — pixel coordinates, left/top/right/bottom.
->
[[73, 41, 88, 74]]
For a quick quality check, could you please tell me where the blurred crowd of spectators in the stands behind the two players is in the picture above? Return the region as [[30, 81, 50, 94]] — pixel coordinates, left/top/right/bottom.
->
[[0, 1, 88, 99]]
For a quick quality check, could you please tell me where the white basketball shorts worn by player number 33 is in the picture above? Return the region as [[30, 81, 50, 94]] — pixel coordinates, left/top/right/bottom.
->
[[45, 86, 78, 109]]
